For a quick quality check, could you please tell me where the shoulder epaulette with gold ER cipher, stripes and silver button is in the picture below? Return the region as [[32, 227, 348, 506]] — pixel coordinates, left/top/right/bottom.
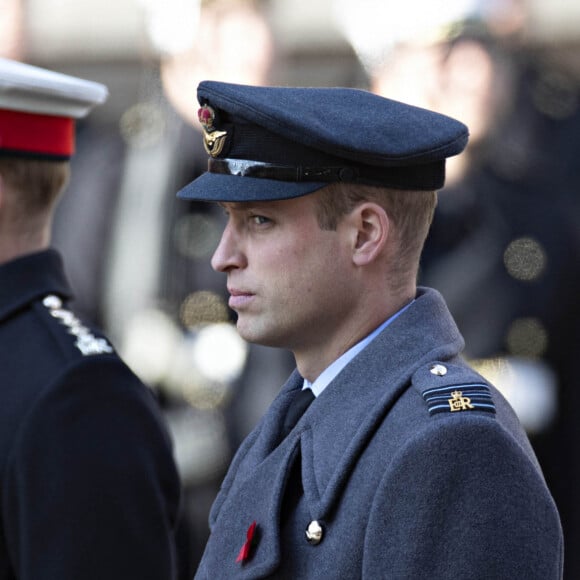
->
[[413, 362, 495, 415]]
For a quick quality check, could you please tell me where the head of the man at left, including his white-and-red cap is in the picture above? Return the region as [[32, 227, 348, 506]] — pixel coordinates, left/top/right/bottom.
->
[[0, 58, 108, 261]]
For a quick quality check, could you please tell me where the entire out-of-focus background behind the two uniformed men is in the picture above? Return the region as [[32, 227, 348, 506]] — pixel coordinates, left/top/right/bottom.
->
[[0, 0, 580, 580]]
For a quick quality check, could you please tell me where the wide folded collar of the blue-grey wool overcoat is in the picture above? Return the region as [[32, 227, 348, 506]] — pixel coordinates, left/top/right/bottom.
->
[[302, 288, 463, 519]]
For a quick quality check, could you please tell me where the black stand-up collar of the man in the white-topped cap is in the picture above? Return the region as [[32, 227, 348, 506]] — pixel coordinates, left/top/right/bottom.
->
[[0, 249, 72, 321]]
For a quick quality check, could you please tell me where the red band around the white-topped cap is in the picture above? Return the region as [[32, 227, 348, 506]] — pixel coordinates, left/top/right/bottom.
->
[[0, 109, 75, 158]]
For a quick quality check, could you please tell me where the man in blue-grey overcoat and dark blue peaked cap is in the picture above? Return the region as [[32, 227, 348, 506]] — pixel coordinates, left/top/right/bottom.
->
[[179, 81, 563, 580]]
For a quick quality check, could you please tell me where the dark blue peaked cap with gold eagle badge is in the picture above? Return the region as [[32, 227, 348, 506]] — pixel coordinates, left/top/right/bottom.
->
[[178, 81, 468, 201]]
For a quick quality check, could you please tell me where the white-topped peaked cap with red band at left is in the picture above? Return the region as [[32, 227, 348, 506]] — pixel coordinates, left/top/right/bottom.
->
[[0, 58, 109, 159]]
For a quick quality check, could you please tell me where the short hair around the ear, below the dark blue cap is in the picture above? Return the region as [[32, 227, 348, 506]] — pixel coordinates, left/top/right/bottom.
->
[[316, 183, 437, 290]]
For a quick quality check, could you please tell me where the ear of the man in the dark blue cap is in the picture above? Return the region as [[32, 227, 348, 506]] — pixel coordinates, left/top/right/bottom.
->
[[350, 202, 391, 266]]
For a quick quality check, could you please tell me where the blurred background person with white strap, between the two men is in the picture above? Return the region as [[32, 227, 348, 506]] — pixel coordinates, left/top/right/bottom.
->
[[97, 0, 291, 577]]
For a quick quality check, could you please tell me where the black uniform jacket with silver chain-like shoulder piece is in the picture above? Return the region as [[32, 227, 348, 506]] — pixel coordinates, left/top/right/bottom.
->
[[0, 250, 179, 580]]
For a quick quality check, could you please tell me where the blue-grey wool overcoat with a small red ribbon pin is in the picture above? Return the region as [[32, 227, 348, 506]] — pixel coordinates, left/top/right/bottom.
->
[[196, 288, 562, 580]]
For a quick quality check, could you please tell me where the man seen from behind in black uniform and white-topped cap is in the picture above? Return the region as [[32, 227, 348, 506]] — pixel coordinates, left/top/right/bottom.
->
[[0, 60, 180, 580]]
